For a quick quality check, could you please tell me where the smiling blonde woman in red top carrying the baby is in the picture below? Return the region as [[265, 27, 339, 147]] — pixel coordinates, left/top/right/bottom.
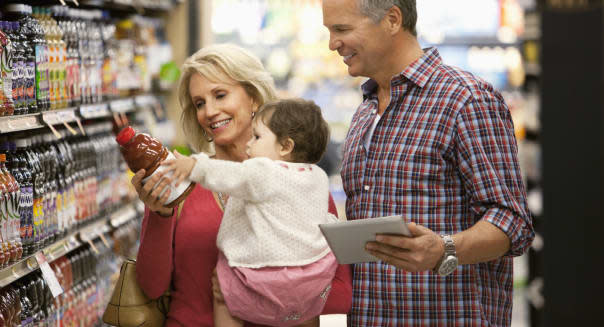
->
[[132, 45, 352, 326]]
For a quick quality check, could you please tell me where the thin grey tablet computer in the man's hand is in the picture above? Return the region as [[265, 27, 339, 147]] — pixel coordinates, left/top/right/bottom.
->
[[319, 216, 411, 264]]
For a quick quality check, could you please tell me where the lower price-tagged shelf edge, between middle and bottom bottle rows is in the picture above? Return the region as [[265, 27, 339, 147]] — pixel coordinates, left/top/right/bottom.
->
[[0, 204, 137, 288]]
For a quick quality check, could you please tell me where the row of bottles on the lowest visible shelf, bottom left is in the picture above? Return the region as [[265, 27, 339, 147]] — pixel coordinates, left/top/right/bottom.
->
[[0, 231, 130, 327]]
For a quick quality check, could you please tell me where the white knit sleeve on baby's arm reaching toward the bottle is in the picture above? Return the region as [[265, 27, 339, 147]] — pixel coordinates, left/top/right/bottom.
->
[[189, 153, 279, 202]]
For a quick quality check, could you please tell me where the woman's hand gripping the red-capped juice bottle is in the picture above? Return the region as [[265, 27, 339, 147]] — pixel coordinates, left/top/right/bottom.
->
[[131, 169, 173, 216]]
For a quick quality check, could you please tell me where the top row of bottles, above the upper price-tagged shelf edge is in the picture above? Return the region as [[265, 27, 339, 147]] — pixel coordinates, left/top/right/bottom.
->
[[0, 4, 169, 115]]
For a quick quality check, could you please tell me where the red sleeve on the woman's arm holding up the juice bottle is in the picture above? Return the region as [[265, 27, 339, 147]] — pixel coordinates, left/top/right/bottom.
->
[[136, 207, 177, 299]]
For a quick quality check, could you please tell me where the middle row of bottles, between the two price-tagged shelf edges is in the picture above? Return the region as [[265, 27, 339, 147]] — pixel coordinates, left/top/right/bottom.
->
[[0, 122, 129, 267]]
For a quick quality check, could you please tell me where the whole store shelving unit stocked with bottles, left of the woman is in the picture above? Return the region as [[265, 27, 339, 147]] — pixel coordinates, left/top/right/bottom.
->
[[0, 0, 184, 326]]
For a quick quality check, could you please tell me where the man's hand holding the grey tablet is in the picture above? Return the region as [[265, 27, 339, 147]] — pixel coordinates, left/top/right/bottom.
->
[[365, 223, 445, 272]]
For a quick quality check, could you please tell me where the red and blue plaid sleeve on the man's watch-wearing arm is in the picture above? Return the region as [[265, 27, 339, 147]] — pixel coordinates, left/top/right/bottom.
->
[[456, 95, 534, 256]]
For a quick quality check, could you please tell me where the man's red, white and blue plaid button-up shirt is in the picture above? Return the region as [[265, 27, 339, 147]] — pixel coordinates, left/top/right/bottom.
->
[[341, 48, 534, 326]]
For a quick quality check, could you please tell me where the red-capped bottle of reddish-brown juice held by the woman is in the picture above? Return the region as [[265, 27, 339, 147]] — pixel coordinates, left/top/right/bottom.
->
[[116, 126, 195, 208]]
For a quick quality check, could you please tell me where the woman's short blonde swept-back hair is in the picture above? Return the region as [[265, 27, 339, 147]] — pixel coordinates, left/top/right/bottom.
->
[[178, 44, 277, 152]]
